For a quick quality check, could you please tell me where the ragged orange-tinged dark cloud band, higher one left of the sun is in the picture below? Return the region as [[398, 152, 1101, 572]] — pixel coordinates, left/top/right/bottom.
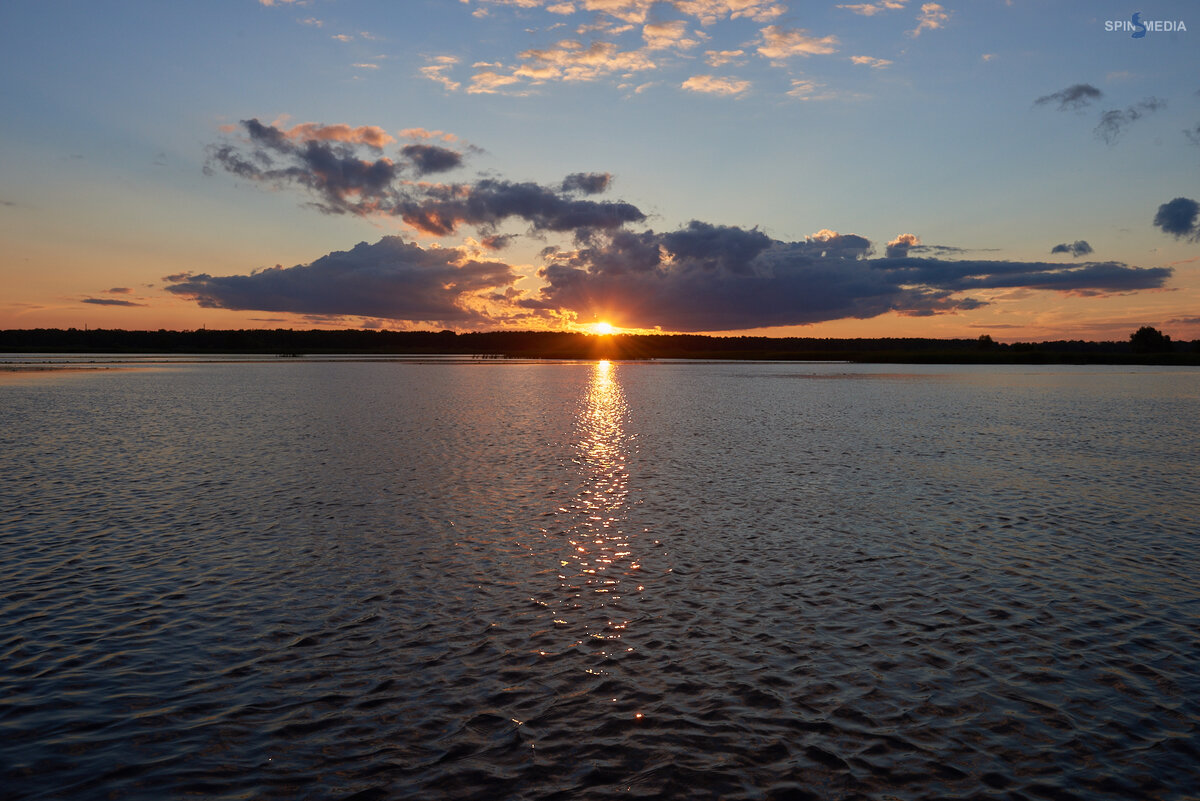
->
[[205, 119, 646, 236]]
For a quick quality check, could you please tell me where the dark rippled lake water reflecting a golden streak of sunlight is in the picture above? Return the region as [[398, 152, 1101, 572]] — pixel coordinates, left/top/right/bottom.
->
[[0, 360, 1200, 800]]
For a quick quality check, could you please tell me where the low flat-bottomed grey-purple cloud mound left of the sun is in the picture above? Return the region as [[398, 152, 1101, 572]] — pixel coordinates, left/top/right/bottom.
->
[[167, 236, 520, 325]]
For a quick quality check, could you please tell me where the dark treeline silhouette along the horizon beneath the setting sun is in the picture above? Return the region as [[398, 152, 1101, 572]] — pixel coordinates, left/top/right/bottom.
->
[[0, 326, 1200, 365]]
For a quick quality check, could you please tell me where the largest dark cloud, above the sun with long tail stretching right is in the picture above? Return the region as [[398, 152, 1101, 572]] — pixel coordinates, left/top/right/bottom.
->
[[520, 222, 1171, 331]]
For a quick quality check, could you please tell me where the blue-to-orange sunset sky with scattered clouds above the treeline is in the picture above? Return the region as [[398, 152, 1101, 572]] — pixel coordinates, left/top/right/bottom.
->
[[0, 0, 1200, 341]]
